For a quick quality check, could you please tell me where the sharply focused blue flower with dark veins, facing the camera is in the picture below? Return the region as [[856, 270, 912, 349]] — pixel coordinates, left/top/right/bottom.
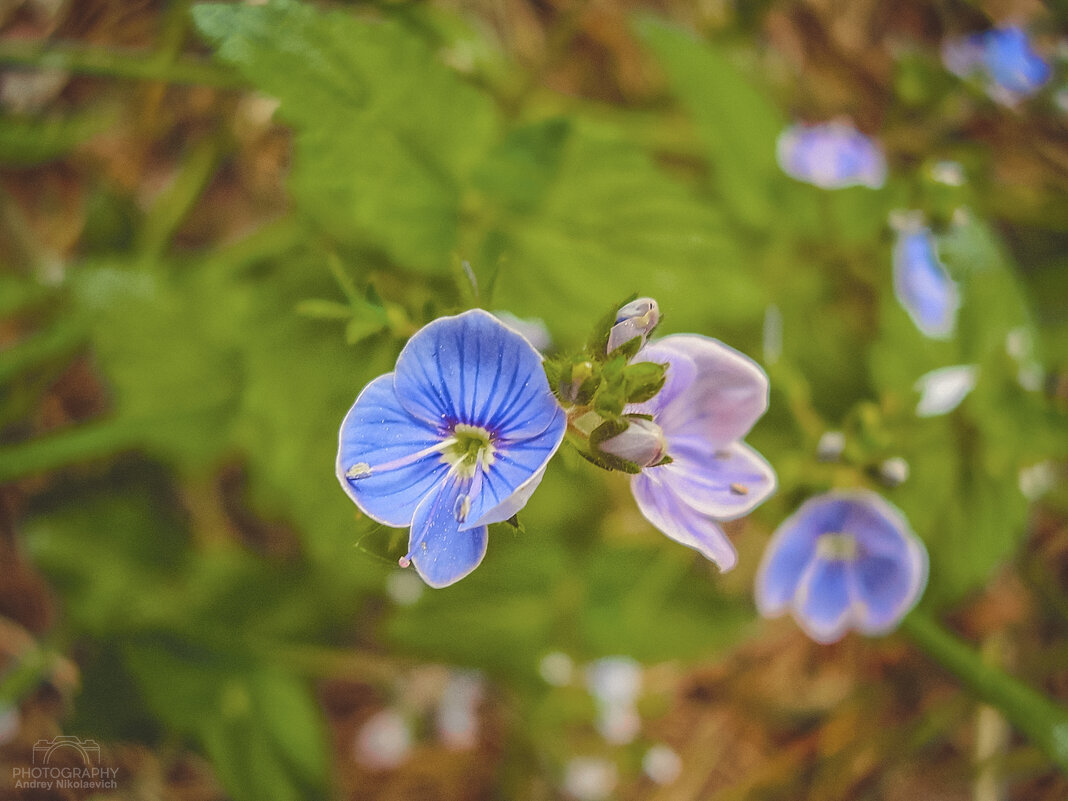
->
[[337, 309, 566, 587]]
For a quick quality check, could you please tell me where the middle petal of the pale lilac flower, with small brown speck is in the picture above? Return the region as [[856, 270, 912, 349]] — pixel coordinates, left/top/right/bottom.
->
[[646, 438, 775, 520]]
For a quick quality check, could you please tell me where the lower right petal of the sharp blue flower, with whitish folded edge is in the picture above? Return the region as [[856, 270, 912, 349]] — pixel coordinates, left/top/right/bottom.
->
[[462, 406, 567, 529]]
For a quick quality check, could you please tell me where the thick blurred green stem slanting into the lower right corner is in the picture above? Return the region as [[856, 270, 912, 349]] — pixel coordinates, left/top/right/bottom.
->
[[901, 611, 1068, 773]]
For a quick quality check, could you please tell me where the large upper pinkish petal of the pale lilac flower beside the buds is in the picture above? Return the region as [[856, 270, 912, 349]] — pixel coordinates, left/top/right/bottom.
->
[[656, 334, 768, 449]]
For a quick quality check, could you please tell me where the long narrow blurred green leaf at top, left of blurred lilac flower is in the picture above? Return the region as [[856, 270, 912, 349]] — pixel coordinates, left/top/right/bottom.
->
[[635, 17, 784, 227]]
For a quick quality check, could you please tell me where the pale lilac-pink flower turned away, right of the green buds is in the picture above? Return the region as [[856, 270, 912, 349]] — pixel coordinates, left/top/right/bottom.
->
[[627, 334, 775, 570]]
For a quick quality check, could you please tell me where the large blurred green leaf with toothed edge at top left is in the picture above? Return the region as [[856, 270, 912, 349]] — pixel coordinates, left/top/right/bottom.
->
[[193, 0, 497, 271]]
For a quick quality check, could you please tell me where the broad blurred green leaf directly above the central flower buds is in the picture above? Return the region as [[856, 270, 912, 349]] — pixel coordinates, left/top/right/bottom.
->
[[484, 127, 765, 341]]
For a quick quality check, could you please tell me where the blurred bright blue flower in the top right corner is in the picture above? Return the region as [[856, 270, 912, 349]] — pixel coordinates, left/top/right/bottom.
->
[[942, 26, 1052, 104]]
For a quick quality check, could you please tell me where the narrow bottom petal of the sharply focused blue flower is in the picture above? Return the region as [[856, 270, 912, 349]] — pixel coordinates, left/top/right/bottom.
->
[[408, 476, 489, 587]]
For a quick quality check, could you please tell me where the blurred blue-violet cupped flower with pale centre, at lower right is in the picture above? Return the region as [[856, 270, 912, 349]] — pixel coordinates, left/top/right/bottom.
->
[[756, 490, 927, 643]]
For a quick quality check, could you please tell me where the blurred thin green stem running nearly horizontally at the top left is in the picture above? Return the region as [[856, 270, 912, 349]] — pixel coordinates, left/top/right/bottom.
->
[[0, 42, 246, 89]]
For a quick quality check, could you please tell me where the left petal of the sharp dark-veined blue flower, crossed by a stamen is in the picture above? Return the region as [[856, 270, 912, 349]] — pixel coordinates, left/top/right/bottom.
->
[[336, 373, 447, 527]]
